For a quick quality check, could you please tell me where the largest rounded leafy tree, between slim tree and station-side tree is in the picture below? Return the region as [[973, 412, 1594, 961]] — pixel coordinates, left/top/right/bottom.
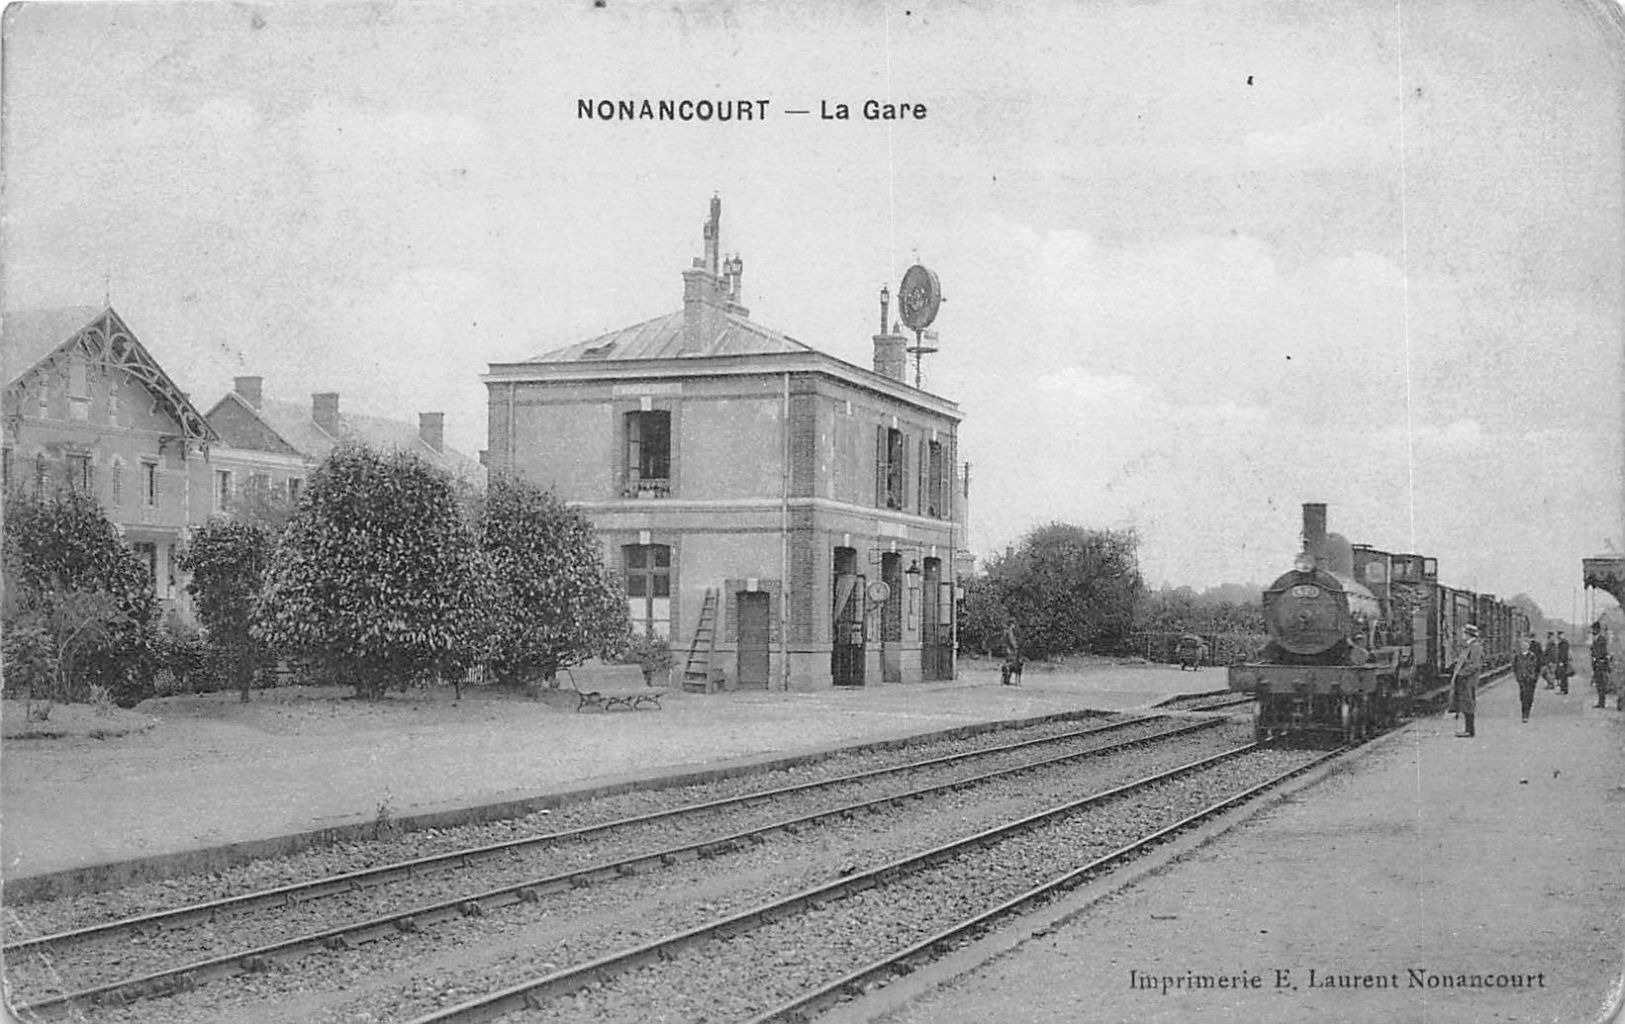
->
[[254, 445, 484, 698]]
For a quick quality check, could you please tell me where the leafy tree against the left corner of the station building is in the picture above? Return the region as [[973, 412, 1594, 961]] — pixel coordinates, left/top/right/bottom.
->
[[475, 477, 630, 682]]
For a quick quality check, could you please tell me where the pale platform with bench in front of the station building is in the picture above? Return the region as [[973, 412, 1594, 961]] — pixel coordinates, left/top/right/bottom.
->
[[0, 661, 1225, 901]]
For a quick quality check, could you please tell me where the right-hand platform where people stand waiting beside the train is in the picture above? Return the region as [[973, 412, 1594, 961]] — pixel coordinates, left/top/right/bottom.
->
[[864, 669, 1625, 1023]]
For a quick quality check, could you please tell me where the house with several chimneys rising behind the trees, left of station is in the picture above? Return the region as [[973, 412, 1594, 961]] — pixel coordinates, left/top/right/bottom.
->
[[205, 375, 486, 513]]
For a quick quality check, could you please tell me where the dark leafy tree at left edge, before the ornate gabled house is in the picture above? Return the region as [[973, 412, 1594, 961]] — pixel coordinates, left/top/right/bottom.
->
[[3, 492, 158, 706]]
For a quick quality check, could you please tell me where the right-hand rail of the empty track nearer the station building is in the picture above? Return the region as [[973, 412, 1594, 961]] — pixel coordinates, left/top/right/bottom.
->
[[15, 718, 1224, 1020]]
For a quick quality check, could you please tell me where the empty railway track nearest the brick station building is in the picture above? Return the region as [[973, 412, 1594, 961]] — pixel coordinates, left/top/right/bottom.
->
[[5, 716, 1224, 1020]]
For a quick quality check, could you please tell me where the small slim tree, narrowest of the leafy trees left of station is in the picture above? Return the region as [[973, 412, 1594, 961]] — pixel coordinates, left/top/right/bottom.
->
[[180, 518, 271, 703]]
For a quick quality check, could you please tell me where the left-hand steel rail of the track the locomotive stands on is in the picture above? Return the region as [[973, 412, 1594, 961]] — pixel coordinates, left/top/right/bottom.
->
[[416, 742, 1259, 1025]]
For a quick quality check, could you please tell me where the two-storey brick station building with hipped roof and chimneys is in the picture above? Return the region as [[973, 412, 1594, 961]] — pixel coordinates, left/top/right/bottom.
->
[[484, 198, 965, 690]]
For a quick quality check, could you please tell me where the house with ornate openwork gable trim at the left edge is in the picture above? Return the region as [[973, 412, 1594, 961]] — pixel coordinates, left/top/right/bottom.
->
[[0, 307, 218, 614]]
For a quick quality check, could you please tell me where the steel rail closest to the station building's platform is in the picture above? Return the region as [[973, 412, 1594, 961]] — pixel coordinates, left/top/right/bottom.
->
[[0, 713, 1165, 960]]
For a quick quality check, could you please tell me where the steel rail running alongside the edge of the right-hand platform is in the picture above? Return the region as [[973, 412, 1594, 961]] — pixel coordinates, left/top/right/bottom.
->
[[752, 742, 1365, 1025]]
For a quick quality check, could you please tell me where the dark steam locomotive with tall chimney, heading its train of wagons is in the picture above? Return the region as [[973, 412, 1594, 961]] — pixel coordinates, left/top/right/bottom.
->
[[1230, 503, 1529, 742]]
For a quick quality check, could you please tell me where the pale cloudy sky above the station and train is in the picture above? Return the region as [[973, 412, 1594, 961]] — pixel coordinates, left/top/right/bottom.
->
[[0, 0, 1625, 617]]
